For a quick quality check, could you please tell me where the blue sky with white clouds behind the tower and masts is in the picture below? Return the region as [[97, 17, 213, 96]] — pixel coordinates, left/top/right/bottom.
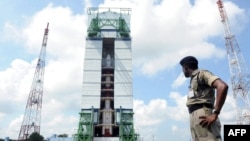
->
[[0, 0, 250, 141]]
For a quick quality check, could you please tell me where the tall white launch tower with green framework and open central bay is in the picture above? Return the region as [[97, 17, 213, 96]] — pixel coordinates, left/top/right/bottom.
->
[[74, 8, 140, 141]]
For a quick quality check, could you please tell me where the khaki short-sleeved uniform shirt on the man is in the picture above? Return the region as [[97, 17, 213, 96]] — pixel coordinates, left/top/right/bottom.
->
[[186, 69, 219, 107]]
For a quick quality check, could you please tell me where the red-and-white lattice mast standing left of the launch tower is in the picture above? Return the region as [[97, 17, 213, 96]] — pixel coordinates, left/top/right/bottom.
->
[[18, 23, 49, 141]]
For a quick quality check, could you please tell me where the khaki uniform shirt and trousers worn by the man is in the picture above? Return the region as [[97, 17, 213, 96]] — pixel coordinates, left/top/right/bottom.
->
[[187, 69, 221, 141]]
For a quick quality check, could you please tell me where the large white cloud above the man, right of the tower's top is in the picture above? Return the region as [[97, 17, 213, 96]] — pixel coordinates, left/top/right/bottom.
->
[[97, 0, 244, 75]]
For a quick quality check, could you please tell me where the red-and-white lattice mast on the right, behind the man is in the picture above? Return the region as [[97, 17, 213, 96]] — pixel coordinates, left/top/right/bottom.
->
[[217, 0, 250, 124]]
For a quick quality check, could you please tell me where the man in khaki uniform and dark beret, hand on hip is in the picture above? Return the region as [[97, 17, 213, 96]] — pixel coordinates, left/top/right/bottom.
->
[[180, 56, 228, 141]]
